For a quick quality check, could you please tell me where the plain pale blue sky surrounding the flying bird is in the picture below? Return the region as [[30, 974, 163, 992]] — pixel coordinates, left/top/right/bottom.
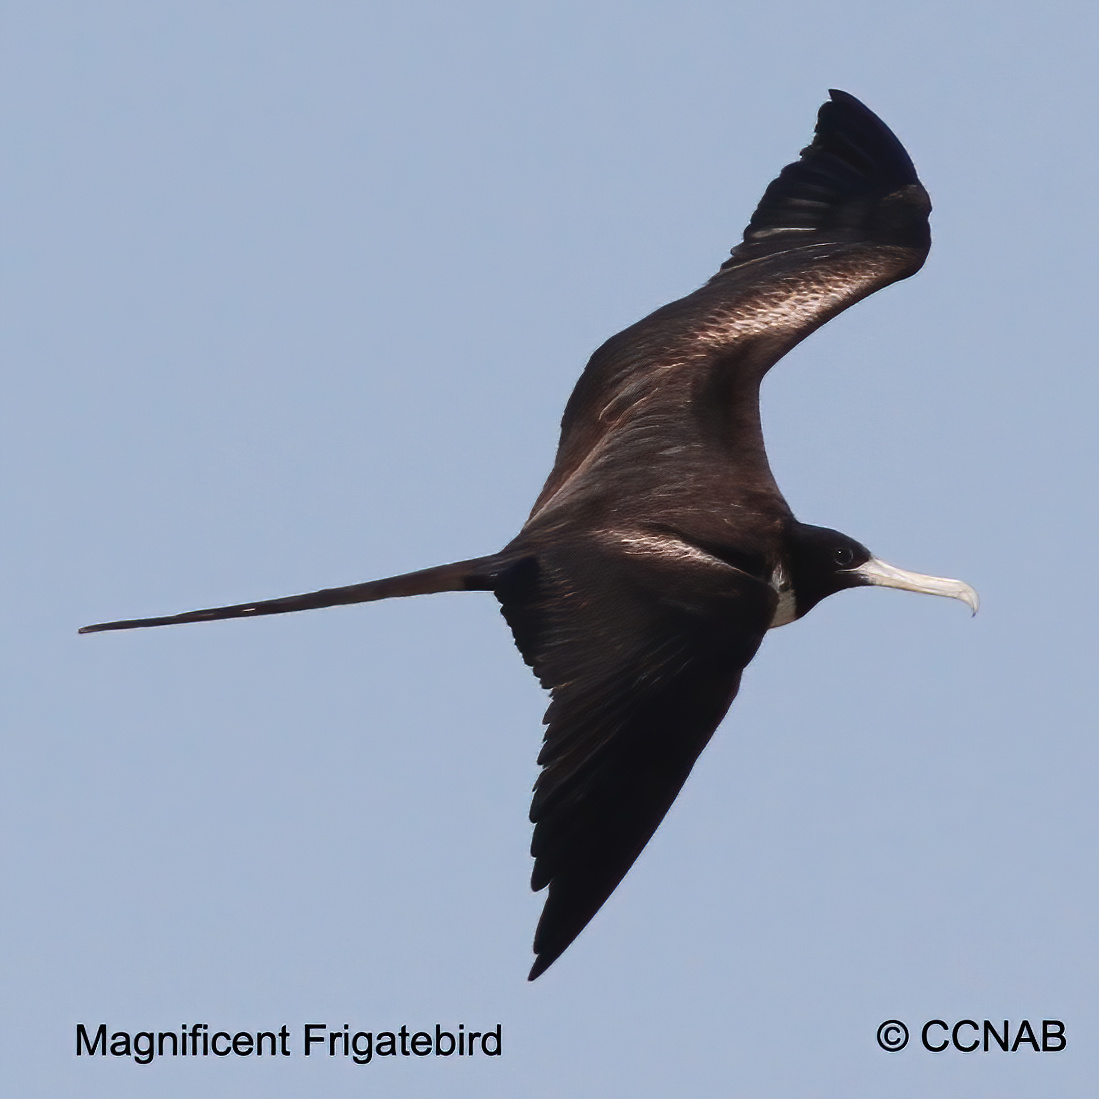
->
[[0, 0, 1099, 1099]]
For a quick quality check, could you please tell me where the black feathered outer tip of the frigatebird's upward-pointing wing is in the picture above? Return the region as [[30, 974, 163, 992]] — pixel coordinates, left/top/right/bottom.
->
[[723, 88, 931, 268]]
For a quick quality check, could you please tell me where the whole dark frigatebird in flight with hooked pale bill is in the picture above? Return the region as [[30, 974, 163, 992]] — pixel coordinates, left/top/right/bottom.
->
[[80, 91, 977, 980]]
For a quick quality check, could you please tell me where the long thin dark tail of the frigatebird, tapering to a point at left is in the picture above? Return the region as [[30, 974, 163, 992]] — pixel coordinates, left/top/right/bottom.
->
[[79, 554, 502, 633]]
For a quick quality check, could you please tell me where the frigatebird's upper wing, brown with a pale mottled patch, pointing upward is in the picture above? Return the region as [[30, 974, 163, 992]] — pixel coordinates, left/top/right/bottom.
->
[[531, 91, 931, 520]]
